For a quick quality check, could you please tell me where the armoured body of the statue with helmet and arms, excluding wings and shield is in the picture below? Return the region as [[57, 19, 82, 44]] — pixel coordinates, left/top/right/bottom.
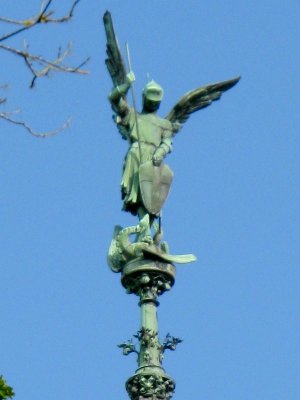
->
[[109, 72, 176, 239]]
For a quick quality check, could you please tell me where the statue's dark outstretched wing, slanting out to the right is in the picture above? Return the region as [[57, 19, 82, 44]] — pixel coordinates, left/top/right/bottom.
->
[[165, 77, 240, 130]]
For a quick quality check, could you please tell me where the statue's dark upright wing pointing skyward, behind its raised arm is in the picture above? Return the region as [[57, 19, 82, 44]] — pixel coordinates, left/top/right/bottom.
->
[[103, 11, 126, 86]]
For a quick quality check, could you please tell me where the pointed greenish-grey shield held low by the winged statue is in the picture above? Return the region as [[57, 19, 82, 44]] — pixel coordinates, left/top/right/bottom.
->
[[139, 161, 173, 216]]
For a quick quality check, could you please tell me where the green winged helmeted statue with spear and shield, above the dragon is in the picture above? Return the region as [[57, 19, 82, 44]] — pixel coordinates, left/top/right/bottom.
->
[[103, 11, 240, 250]]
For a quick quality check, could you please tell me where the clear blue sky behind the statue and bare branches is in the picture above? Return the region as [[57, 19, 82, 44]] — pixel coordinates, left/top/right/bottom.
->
[[0, 0, 300, 400]]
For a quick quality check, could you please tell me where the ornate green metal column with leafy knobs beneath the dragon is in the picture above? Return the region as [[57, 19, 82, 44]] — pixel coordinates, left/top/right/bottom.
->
[[121, 259, 181, 400]]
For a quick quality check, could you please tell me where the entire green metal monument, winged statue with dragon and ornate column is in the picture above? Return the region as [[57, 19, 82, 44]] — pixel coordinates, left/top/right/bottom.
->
[[103, 11, 240, 400]]
